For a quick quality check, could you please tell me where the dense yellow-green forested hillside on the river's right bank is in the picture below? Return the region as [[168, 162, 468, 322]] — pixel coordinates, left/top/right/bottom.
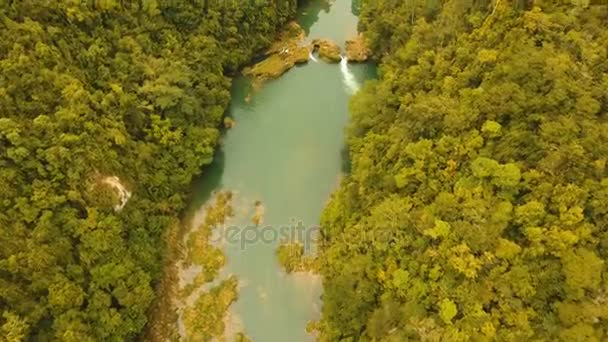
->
[[318, 0, 608, 342]]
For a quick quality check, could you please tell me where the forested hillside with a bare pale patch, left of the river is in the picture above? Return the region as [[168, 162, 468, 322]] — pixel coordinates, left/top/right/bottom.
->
[[0, 0, 297, 341]]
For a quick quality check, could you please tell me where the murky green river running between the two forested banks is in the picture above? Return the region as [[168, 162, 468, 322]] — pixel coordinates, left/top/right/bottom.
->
[[185, 0, 375, 342]]
